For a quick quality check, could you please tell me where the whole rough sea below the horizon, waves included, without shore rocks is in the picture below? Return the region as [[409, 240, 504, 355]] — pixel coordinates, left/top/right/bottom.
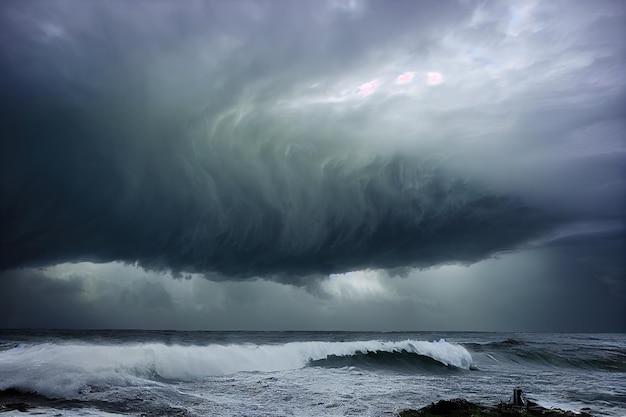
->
[[0, 330, 626, 416]]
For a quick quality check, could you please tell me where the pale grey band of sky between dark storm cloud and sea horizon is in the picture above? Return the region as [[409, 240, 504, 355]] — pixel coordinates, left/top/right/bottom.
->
[[0, 238, 626, 332]]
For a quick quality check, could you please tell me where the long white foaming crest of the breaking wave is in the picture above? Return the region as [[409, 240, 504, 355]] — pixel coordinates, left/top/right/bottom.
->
[[0, 340, 472, 397]]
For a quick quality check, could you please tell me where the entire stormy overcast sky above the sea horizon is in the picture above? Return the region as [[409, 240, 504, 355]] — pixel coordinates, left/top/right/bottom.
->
[[0, 0, 626, 331]]
